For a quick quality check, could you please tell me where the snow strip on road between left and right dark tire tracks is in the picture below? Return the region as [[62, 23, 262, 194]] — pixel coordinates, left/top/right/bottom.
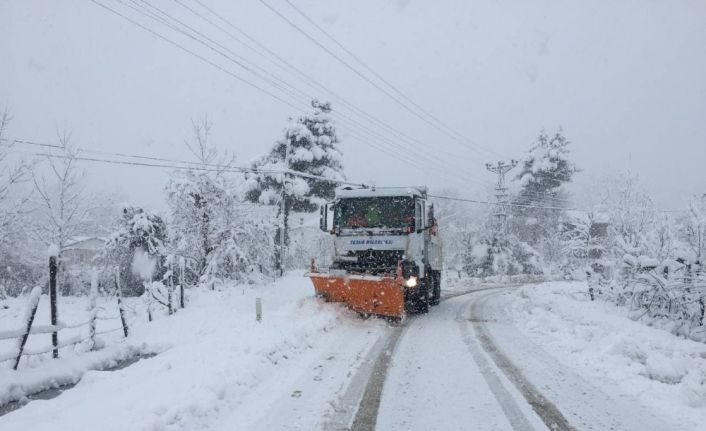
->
[[377, 294, 541, 430]]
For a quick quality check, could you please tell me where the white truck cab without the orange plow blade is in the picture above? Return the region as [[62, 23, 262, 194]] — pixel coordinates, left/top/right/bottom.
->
[[320, 187, 442, 305]]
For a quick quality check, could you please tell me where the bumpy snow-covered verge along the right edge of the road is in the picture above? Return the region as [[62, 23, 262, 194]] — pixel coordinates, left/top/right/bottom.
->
[[508, 282, 706, 429]]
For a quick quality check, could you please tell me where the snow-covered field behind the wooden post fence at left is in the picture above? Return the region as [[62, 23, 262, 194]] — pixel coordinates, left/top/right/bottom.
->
[[0, 294, 147, 405]]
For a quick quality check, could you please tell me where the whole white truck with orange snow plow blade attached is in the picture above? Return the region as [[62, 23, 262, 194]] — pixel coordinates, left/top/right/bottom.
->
[[307, 187, 442, 319]]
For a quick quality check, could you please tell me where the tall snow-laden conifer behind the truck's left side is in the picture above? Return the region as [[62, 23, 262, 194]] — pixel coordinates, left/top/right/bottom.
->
[[246, 100, 345, 268]]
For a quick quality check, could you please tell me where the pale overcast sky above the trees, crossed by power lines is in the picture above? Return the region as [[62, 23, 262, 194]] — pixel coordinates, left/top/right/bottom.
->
[[0, 0, 706, 208]]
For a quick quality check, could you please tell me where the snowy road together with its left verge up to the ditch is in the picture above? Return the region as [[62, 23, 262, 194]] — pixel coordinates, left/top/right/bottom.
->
[[0, 277, 699, 431]]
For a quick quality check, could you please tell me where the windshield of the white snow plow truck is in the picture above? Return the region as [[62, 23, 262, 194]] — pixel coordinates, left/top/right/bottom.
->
[[336, 196, 414, 229]]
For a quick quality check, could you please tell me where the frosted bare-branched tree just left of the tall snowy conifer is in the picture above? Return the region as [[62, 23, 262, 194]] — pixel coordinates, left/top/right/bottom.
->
[[166, 116, 274, 286]]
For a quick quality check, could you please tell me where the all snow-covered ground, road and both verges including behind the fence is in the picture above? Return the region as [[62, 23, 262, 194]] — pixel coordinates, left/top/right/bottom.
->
[[0, 273, 706, 431]]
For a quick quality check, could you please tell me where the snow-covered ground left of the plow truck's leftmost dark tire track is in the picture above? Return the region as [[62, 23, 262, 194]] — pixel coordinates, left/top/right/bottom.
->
[[0, 273, 387, 431]]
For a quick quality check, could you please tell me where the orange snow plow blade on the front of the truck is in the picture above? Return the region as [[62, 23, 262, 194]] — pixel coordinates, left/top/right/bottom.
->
[[307, 271, 405, 318]]
